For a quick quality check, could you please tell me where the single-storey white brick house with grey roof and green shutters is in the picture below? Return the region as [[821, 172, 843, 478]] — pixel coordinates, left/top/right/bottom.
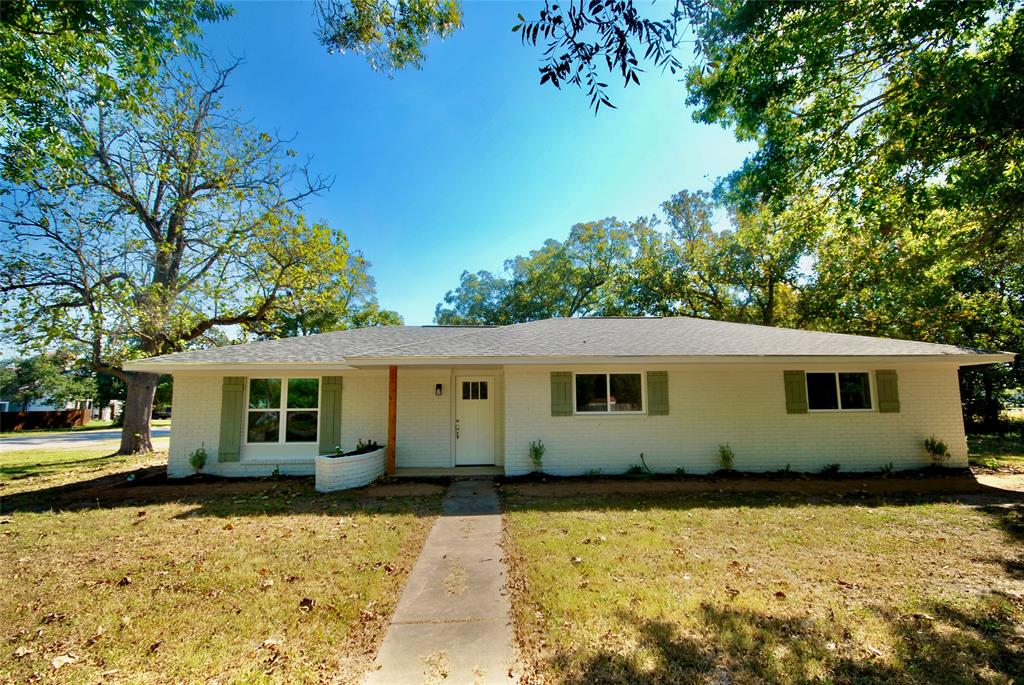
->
[[126, 317, 1014, 476]]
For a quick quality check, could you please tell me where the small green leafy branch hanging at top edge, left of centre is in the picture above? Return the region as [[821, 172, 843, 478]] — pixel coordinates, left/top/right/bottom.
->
[[316, 0, 462, 72]]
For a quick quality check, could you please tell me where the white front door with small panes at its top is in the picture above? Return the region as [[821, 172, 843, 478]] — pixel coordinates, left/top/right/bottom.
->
[[455, 376, 495, 466]]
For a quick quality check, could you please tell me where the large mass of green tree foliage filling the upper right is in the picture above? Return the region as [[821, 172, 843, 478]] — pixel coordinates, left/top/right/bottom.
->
[[517, 0, 1024, 417]]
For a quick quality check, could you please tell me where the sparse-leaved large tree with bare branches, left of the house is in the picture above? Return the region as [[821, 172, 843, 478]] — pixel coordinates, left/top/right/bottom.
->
[[0, 61, 351, 453]]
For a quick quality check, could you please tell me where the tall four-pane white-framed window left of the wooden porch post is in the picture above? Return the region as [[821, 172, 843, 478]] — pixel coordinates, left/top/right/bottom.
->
[[246, 378, 319, 443]]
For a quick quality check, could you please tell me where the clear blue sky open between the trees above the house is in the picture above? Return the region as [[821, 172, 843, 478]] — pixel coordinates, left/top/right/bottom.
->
[[204, 1, 749, 324]]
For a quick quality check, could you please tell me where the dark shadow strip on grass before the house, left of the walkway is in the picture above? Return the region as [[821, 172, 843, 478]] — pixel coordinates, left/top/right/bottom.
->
[[0, 458, 440, 518]]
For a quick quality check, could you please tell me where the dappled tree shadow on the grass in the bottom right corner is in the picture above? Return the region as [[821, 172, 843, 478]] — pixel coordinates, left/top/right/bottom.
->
[[549, 595, 1024, 685]]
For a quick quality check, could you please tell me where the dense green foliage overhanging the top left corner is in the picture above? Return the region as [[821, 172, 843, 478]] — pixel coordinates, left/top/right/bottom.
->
[[0, 0, 232, 180]]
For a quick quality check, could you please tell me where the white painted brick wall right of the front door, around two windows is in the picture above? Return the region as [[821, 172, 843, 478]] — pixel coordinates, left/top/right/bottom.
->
[[505, 363, 967, 475]]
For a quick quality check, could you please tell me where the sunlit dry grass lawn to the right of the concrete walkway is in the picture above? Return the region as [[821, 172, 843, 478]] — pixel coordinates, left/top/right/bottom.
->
[[503, 484, 1024, 685]]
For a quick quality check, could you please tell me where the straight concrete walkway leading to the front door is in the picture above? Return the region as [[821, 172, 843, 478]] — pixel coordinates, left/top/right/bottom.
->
[[365, 480, 515, 685]]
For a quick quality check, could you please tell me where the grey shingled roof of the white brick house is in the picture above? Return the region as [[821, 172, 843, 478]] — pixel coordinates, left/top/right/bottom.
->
[[126, 316, 1014, 372]]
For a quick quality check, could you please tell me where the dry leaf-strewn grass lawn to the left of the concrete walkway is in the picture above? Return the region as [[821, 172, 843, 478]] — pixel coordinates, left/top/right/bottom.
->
[[0, 451, 440, 683]]
